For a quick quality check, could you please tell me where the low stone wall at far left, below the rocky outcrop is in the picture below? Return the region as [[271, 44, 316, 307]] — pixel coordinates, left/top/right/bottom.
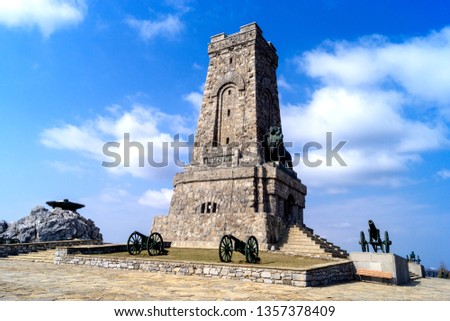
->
[[0, 240, 102, 257]]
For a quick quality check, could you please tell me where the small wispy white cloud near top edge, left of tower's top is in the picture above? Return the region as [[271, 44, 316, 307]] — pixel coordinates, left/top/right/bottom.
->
[[126, 14, 184, 40]]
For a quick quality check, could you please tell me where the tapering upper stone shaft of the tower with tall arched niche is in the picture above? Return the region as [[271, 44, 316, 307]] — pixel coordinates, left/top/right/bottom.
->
[[193, 23, 281, 164]]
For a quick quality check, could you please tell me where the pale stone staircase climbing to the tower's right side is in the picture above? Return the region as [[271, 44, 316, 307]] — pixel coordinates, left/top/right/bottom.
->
[[280, 225, 348, 258]]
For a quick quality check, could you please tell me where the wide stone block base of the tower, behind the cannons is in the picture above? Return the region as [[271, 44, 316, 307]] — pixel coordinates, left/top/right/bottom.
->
[[151, 164, 306, 250]]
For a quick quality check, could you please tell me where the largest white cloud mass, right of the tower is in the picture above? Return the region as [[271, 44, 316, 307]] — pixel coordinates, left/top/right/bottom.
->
[[282, 29, 450, 190]]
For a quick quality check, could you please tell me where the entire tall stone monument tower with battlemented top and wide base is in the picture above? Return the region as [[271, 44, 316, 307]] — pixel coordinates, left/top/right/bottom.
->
[[152, 23, 348, 256]]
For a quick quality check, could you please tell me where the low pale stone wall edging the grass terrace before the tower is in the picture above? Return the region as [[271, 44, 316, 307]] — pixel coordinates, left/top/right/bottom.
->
[[54, 248, 354, 287]]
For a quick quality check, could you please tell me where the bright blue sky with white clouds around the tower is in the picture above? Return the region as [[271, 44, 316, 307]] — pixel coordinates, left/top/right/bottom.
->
[[0, 0, 450, 267]]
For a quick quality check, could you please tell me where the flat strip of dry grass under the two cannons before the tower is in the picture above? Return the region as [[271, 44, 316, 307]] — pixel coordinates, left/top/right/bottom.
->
[[95, 248, 335, 269]]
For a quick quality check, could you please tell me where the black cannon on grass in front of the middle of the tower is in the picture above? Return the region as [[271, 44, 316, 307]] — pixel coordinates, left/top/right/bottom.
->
[[219, 234, 259, 263]]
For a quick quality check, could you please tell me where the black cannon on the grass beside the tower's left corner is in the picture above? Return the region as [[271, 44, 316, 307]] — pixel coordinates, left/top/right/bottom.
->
[[127, 231, 169, 256]]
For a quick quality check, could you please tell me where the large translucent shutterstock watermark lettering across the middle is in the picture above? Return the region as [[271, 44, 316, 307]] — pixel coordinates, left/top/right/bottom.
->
[[102, 132, 347, 168]]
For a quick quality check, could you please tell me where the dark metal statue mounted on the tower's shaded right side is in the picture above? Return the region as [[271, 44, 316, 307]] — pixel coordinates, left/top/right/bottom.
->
[[264, 126, 292, 169]]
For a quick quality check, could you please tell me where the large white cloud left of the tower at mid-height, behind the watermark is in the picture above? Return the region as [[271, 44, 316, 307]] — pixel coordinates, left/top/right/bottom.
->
[[40, 104, 192, 178]]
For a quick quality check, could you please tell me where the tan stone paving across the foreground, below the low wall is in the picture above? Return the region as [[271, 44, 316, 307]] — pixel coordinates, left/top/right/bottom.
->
[[0, 259, 450, 301]]
